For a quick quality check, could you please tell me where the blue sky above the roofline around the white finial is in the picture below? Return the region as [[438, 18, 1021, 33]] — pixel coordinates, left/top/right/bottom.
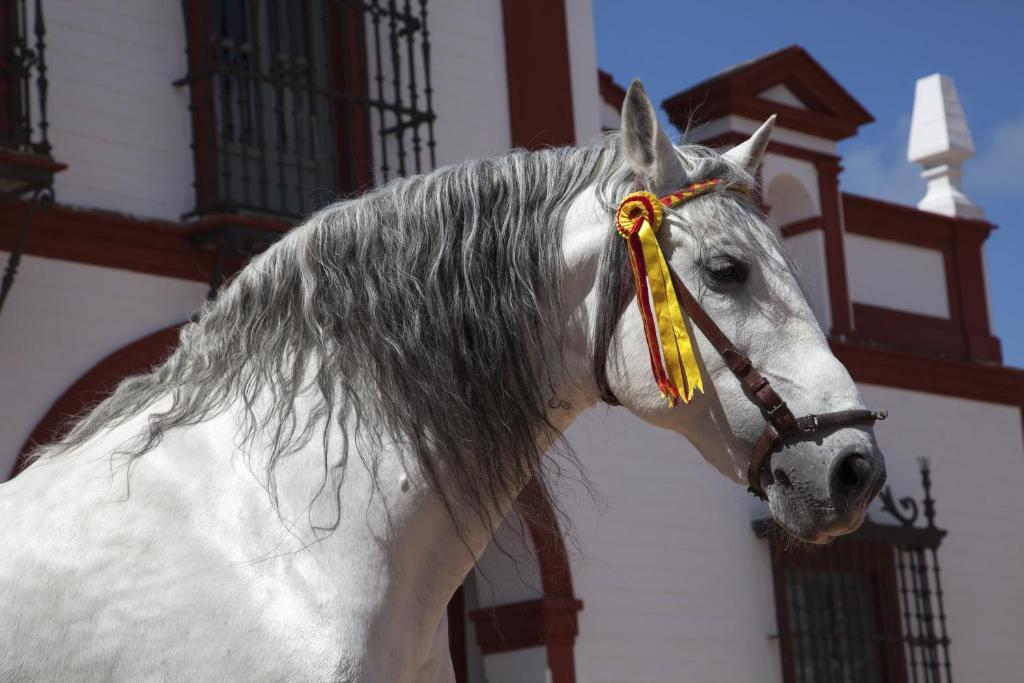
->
[[594, 0, 1024, 367]]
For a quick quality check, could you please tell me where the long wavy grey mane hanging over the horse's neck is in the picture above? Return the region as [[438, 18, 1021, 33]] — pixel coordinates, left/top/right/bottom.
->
[[32, 134, 765, 522]]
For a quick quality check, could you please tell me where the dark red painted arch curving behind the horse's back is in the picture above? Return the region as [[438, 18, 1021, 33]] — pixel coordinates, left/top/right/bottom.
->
[[11, 323, 184, 476]]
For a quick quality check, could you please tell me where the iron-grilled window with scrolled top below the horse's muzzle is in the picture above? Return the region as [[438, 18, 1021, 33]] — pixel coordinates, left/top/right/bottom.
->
[[755, 461, 952, 683]]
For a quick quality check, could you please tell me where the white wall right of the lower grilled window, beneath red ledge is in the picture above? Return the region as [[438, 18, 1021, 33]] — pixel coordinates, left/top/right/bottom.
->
[[862, 386, 1024, 681]]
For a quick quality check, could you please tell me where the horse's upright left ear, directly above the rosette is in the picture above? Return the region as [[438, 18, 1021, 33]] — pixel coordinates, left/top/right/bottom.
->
[[622, 80, 686, 191]]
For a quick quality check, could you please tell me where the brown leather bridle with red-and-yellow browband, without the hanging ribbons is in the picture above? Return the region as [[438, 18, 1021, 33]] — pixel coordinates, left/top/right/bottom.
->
[[595, 180, 888, 500]]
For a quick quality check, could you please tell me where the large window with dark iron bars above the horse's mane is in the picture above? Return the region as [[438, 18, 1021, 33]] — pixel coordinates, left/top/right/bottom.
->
[[177, 0, 435, 221]]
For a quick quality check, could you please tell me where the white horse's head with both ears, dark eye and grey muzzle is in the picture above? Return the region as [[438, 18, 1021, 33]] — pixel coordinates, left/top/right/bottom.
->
[[566, 82, 885, 543]]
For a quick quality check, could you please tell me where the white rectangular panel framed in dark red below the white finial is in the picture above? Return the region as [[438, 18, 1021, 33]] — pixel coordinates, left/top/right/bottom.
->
[[844, 232, 949, 318]]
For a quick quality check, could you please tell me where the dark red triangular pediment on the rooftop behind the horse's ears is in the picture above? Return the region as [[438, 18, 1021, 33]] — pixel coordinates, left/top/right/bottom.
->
[[663, 45, 873, 140]]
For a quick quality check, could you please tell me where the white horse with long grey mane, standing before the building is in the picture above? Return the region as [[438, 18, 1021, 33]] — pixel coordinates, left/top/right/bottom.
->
[[0, 83, 884, 682]]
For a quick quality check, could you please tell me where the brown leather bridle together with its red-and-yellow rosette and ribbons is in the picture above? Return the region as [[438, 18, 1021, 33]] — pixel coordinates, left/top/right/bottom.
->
[[595, 178, 888, 501]]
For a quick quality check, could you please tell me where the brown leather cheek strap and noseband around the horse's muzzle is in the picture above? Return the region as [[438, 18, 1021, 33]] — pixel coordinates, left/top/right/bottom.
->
[[669, 265, 888, 500]]
